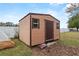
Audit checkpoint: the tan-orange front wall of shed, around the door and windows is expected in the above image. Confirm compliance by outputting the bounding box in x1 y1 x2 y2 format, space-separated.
31 15 59 45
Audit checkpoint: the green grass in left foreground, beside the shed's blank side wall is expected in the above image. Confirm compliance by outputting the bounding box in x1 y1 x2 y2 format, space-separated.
0 39 32 56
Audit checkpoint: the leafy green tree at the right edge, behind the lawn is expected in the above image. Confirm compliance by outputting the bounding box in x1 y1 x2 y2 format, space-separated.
68 14 79 31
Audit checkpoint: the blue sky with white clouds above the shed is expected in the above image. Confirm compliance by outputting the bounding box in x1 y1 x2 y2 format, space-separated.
0 3 69 28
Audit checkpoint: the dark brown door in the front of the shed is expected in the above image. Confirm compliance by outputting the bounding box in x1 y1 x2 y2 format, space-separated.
45 20 53 42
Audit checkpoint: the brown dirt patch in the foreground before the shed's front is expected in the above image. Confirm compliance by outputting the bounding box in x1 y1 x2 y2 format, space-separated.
32 43 79 56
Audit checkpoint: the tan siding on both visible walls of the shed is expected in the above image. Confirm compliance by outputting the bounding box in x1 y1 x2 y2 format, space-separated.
19 15 60 46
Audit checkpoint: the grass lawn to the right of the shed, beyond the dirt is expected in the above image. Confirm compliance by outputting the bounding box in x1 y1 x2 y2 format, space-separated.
59 32 79 46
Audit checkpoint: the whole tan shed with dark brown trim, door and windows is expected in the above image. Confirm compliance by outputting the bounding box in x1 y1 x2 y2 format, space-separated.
19 13 60 47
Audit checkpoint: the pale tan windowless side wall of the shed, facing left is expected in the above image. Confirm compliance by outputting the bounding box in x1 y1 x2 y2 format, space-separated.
19 15 30 45
